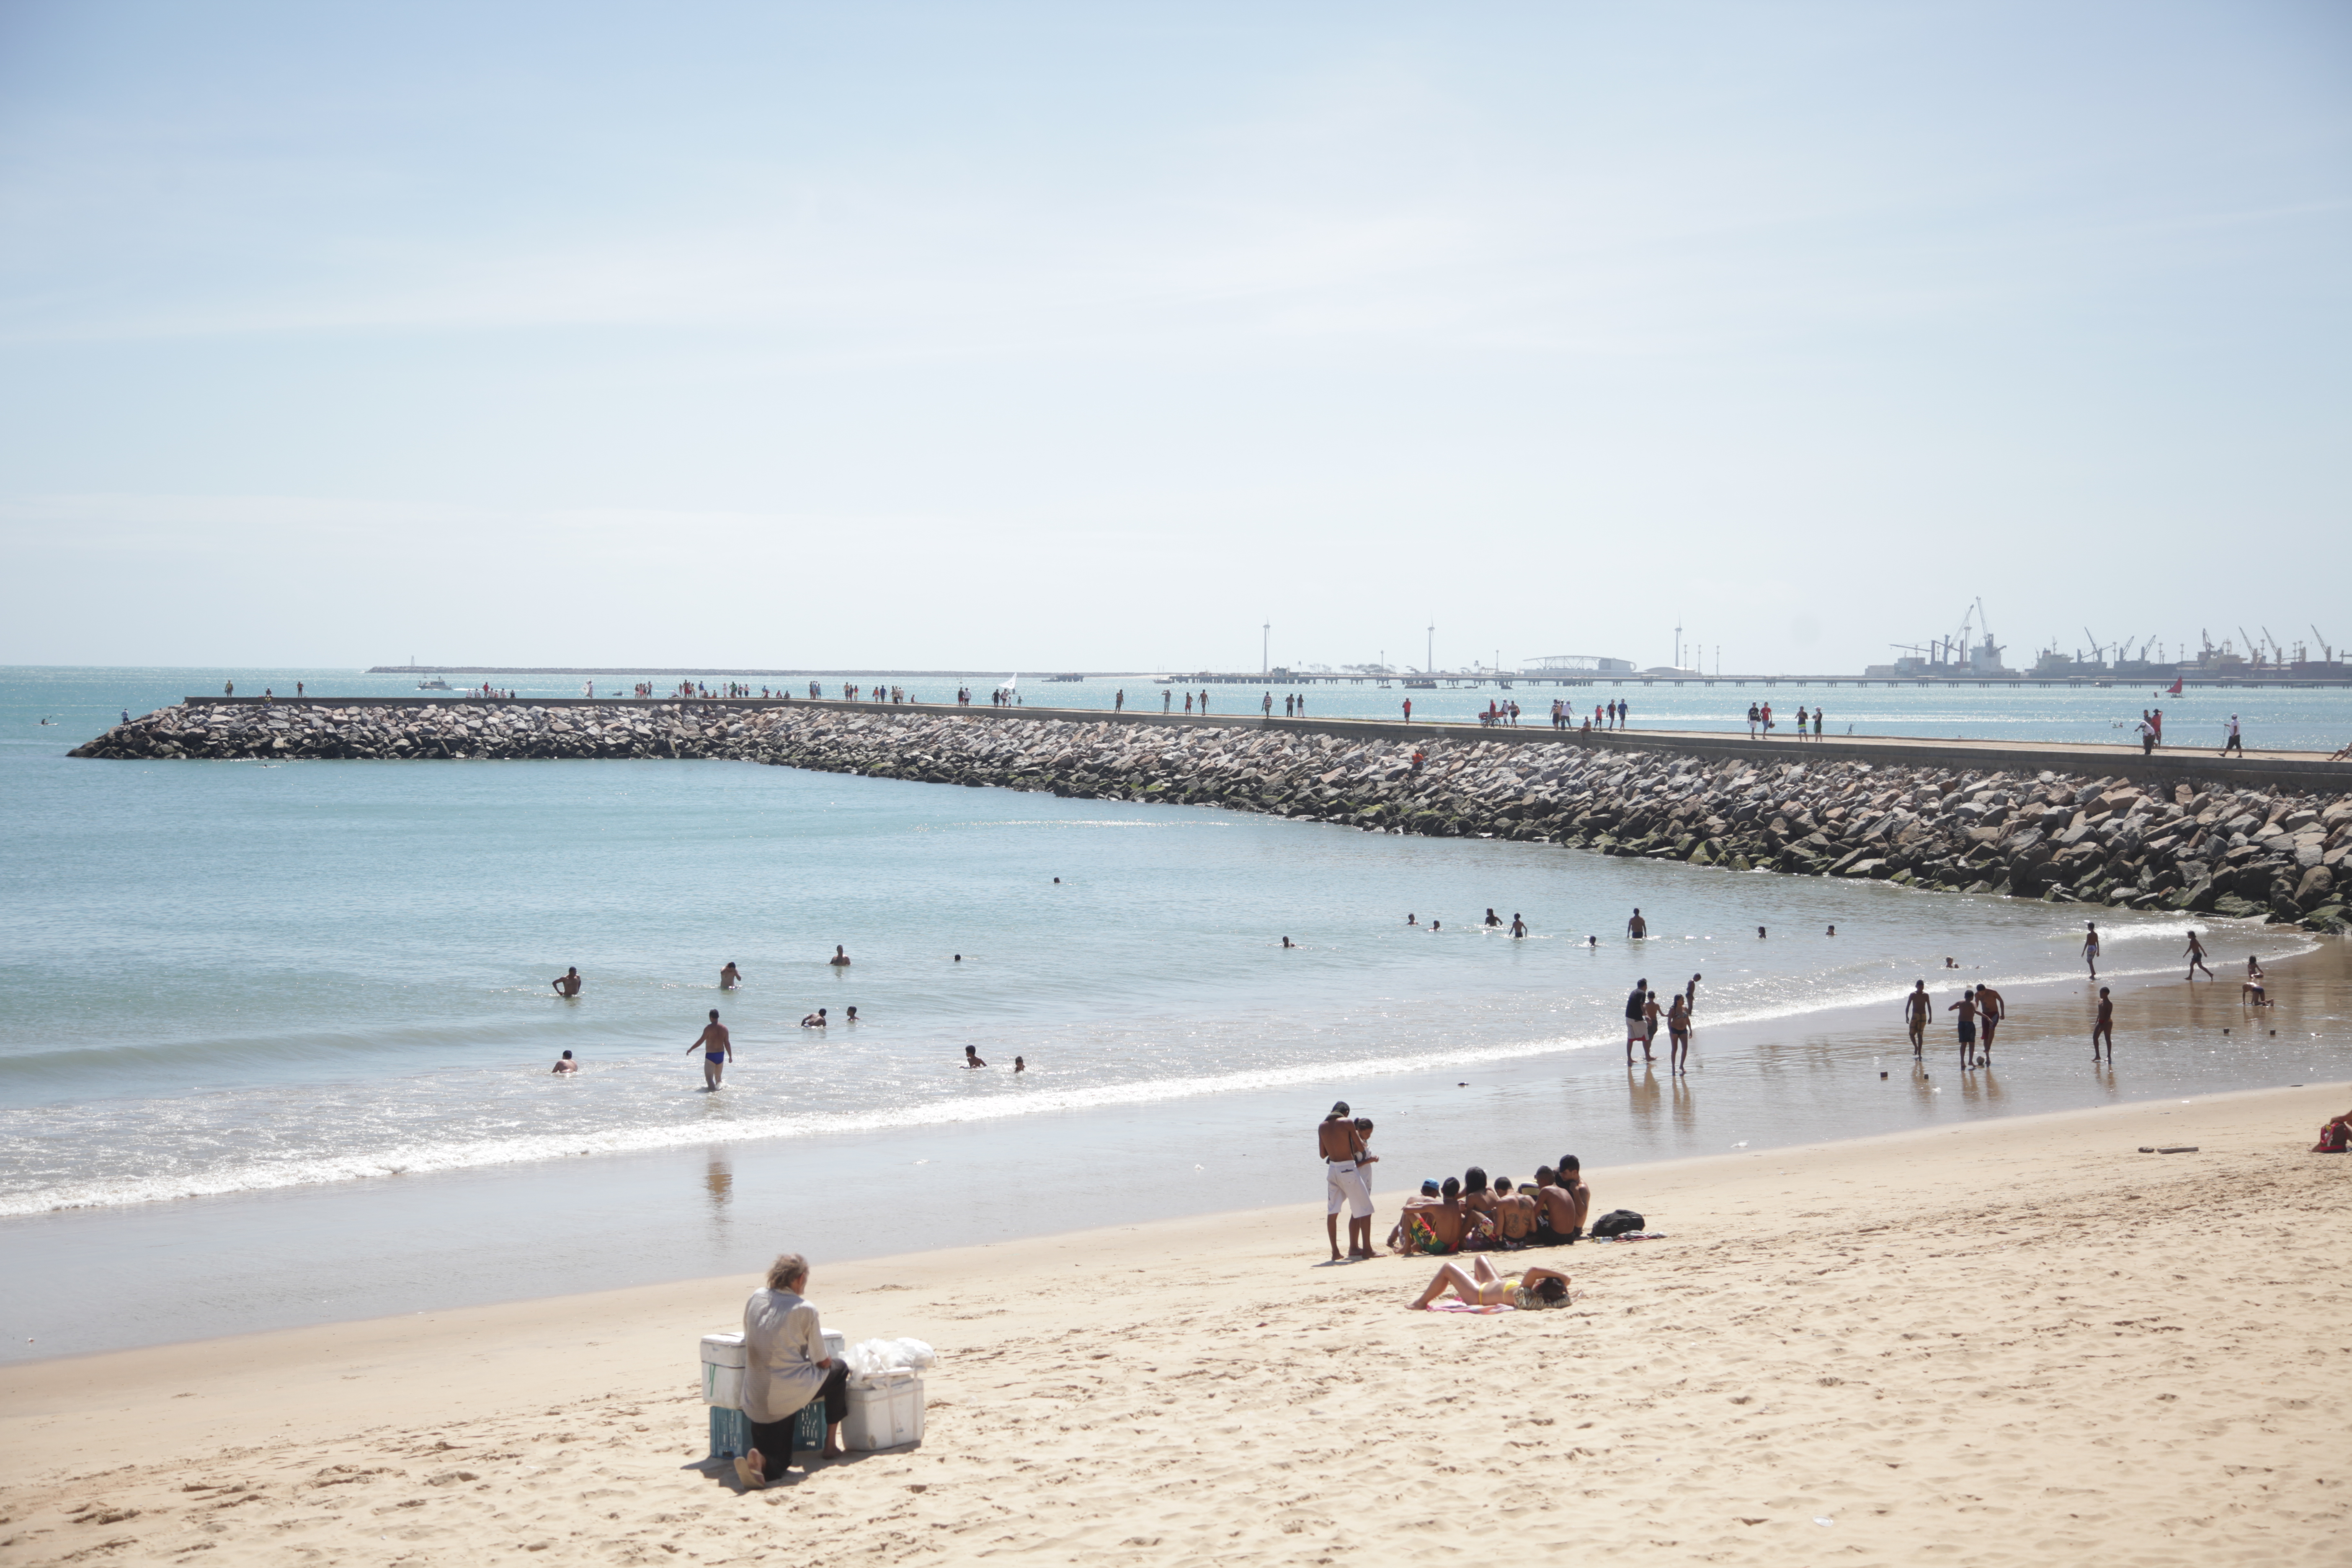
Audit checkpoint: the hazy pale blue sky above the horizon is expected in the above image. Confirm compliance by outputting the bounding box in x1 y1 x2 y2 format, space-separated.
0 0 2352 670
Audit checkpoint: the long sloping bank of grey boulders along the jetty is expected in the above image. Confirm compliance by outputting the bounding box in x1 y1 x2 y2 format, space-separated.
73 698 2352 933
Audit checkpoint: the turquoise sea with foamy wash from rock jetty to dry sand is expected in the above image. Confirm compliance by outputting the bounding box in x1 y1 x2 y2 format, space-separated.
0 670 2352 1357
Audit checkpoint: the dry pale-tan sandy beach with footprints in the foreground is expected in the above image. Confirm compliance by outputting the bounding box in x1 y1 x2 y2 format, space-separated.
0 1067 2352 1563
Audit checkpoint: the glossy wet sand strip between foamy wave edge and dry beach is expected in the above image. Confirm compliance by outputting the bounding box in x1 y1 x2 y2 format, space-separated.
0 938 2352 1366
